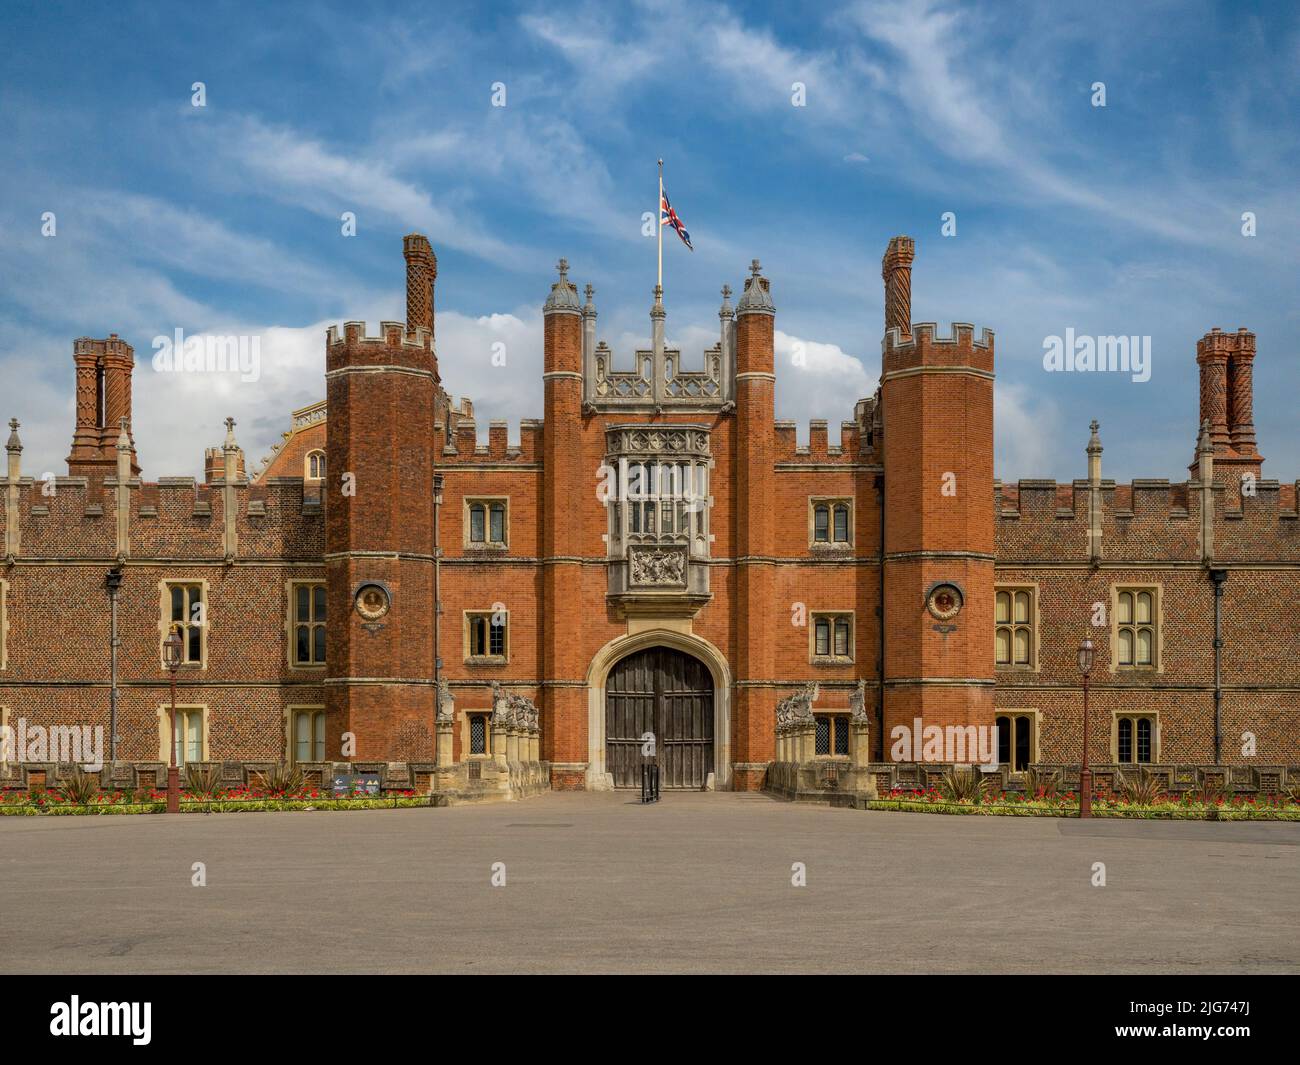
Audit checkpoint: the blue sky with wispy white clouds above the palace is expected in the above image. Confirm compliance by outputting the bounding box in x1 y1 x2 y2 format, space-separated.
0 3 1300 480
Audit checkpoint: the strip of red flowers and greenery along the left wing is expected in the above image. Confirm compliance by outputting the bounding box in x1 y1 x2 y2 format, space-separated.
0 788 432 817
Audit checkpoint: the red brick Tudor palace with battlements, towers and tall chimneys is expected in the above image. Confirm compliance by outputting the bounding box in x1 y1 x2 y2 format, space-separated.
0 235 1300 788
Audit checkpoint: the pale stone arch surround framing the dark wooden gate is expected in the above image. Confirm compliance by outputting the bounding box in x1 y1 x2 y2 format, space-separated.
585 628 731 791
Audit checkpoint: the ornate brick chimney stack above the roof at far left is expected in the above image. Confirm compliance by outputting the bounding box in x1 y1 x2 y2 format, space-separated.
68 333 140 477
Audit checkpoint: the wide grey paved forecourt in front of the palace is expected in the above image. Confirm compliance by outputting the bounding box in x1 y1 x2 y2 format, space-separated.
0 792 1300 973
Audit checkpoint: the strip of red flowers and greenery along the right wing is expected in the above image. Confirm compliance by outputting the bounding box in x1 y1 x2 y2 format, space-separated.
867 788 1300 821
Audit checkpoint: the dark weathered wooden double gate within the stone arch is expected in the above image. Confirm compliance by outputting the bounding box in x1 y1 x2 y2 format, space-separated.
605 648 714 788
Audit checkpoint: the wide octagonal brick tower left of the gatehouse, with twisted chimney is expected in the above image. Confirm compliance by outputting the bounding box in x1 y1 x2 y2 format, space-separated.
324 234 438 762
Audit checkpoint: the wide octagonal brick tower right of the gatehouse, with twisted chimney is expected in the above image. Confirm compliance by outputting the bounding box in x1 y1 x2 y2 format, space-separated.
880 237 995 758
